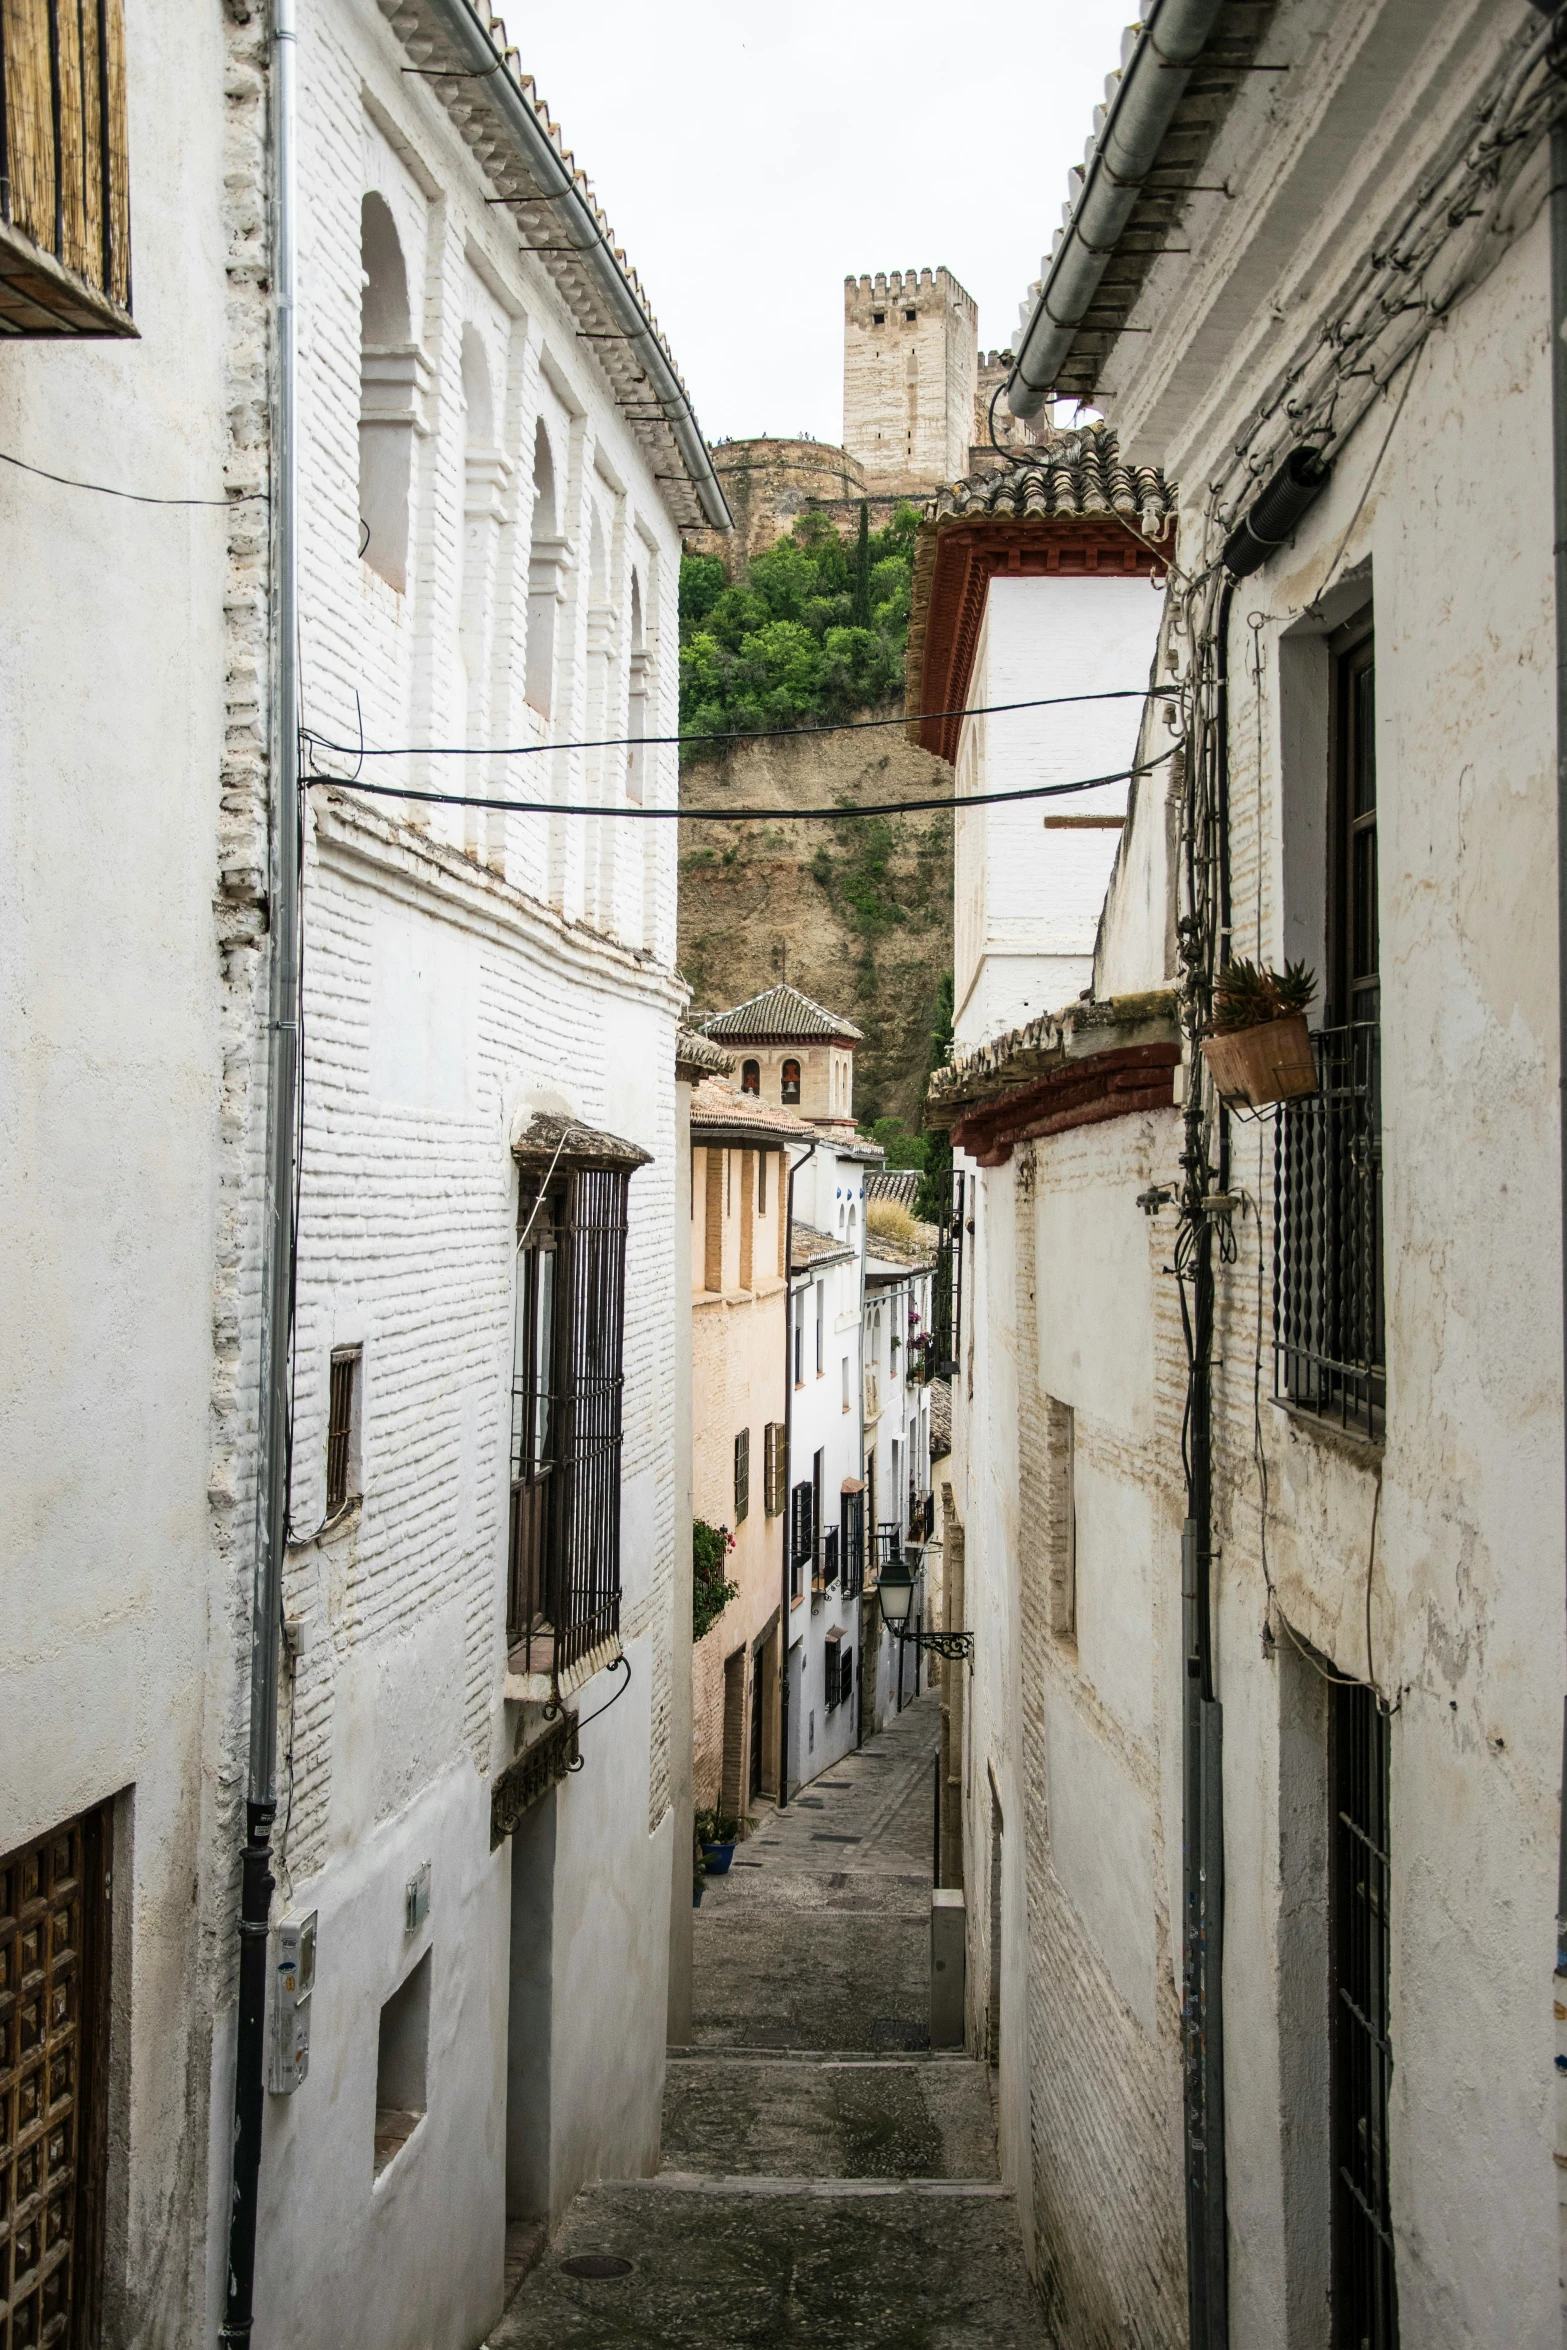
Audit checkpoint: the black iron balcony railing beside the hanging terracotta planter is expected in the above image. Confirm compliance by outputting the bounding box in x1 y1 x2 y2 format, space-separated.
1273 1020 1386 1436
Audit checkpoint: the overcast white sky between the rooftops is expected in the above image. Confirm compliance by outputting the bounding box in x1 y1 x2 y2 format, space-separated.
521 0 1135 442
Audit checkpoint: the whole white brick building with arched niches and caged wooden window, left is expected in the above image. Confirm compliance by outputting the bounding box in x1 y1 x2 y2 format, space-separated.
240 0 724 2350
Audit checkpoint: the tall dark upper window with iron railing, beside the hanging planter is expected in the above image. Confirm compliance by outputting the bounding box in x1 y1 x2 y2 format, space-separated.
1273 625 1386 1436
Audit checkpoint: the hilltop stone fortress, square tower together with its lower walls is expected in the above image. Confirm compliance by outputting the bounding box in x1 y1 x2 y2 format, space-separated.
686 268 1041 571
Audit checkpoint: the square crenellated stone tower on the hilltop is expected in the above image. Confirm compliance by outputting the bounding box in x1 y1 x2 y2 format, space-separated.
843 270 980 494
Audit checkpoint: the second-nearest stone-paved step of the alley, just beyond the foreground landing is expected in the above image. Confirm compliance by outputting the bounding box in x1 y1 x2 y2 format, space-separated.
663 2056 996 2178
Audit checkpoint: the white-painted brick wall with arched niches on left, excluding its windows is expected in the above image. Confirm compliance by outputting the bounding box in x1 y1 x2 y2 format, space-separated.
239 0 691 2350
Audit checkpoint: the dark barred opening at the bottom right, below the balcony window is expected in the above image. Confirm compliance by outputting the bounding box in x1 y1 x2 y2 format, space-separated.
1327 1683 1398 2350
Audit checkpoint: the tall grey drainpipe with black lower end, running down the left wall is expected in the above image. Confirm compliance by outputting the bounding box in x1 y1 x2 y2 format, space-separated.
218 0 301 2350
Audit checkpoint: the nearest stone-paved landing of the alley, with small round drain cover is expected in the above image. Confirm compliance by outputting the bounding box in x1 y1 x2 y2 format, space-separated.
489 2183 1050 2350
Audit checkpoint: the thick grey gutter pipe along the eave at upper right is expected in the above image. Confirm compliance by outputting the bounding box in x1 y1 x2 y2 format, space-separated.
1006 0 1224 416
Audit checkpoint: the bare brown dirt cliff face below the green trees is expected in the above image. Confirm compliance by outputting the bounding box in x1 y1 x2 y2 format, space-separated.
679 726 951 1128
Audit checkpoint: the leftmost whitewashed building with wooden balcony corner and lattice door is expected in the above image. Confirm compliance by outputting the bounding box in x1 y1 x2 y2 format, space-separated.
0 0 247 2350
